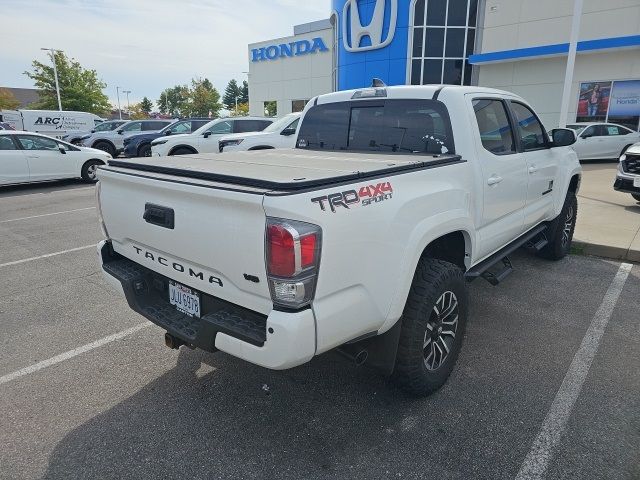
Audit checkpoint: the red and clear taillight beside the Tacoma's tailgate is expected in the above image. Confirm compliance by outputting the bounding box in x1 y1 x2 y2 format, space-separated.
265 218 322 308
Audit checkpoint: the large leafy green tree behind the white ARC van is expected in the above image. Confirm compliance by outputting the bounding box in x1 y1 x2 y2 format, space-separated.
24 51 111 115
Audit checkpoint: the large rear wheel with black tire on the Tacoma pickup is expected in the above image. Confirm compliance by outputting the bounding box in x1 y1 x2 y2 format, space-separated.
392 258 469 396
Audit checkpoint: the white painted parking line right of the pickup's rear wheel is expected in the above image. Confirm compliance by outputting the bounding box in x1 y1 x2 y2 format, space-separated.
516 263 633 480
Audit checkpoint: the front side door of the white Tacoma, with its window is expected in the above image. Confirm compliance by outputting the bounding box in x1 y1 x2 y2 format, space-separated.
509 101 562 230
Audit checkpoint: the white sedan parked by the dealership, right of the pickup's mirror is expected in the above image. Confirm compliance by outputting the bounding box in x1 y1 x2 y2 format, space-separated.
567 123 640 160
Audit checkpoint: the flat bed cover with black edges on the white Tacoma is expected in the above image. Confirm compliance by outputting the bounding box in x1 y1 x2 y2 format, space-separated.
103 149 461 193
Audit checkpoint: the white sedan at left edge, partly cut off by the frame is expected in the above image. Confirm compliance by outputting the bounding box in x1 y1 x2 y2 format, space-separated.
0 130 111 185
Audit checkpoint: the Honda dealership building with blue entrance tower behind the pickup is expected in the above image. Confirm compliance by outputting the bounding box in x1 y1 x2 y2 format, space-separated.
248 0 640 130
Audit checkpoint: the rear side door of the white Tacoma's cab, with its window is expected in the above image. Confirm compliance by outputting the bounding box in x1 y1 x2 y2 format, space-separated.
468 96 527 258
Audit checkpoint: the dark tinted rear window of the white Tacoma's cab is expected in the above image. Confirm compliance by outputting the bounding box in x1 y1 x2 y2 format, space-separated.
298 100 455 155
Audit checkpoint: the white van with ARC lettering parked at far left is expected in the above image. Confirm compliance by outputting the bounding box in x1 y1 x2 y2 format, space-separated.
0 110 104 138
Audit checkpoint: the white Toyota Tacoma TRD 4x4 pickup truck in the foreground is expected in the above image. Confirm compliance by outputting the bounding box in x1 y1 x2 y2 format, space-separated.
98 85 581 395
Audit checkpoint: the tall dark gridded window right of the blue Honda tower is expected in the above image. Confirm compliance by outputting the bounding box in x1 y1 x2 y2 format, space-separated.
411 0 478 85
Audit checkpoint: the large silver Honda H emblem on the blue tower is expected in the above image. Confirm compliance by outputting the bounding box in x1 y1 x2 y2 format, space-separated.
342 0 398 52
